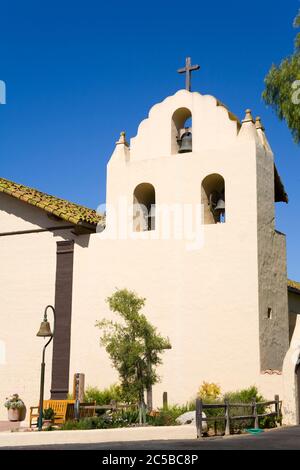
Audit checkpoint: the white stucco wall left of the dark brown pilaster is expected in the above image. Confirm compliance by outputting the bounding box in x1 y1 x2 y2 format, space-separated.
0 194 74 420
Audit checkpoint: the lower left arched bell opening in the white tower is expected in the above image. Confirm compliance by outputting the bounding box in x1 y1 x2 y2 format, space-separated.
133 183 155 232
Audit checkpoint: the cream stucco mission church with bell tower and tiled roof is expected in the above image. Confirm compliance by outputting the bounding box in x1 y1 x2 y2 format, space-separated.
0 67 300 424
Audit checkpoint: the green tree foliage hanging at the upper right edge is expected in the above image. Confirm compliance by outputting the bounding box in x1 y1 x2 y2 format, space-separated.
262 11 300 143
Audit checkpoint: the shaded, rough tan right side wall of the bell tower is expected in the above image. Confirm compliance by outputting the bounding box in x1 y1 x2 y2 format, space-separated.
256 143 289 372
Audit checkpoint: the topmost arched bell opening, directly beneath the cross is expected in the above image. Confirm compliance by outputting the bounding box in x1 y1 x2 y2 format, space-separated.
171 108 193 154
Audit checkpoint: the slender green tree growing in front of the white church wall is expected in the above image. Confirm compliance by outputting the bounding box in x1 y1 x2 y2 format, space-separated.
96 289 171 422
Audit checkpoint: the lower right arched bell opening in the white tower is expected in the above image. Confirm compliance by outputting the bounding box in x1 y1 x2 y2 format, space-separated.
201 173 226 224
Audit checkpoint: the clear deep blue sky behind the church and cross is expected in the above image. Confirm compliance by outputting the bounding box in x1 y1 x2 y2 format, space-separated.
0 0 300 280
